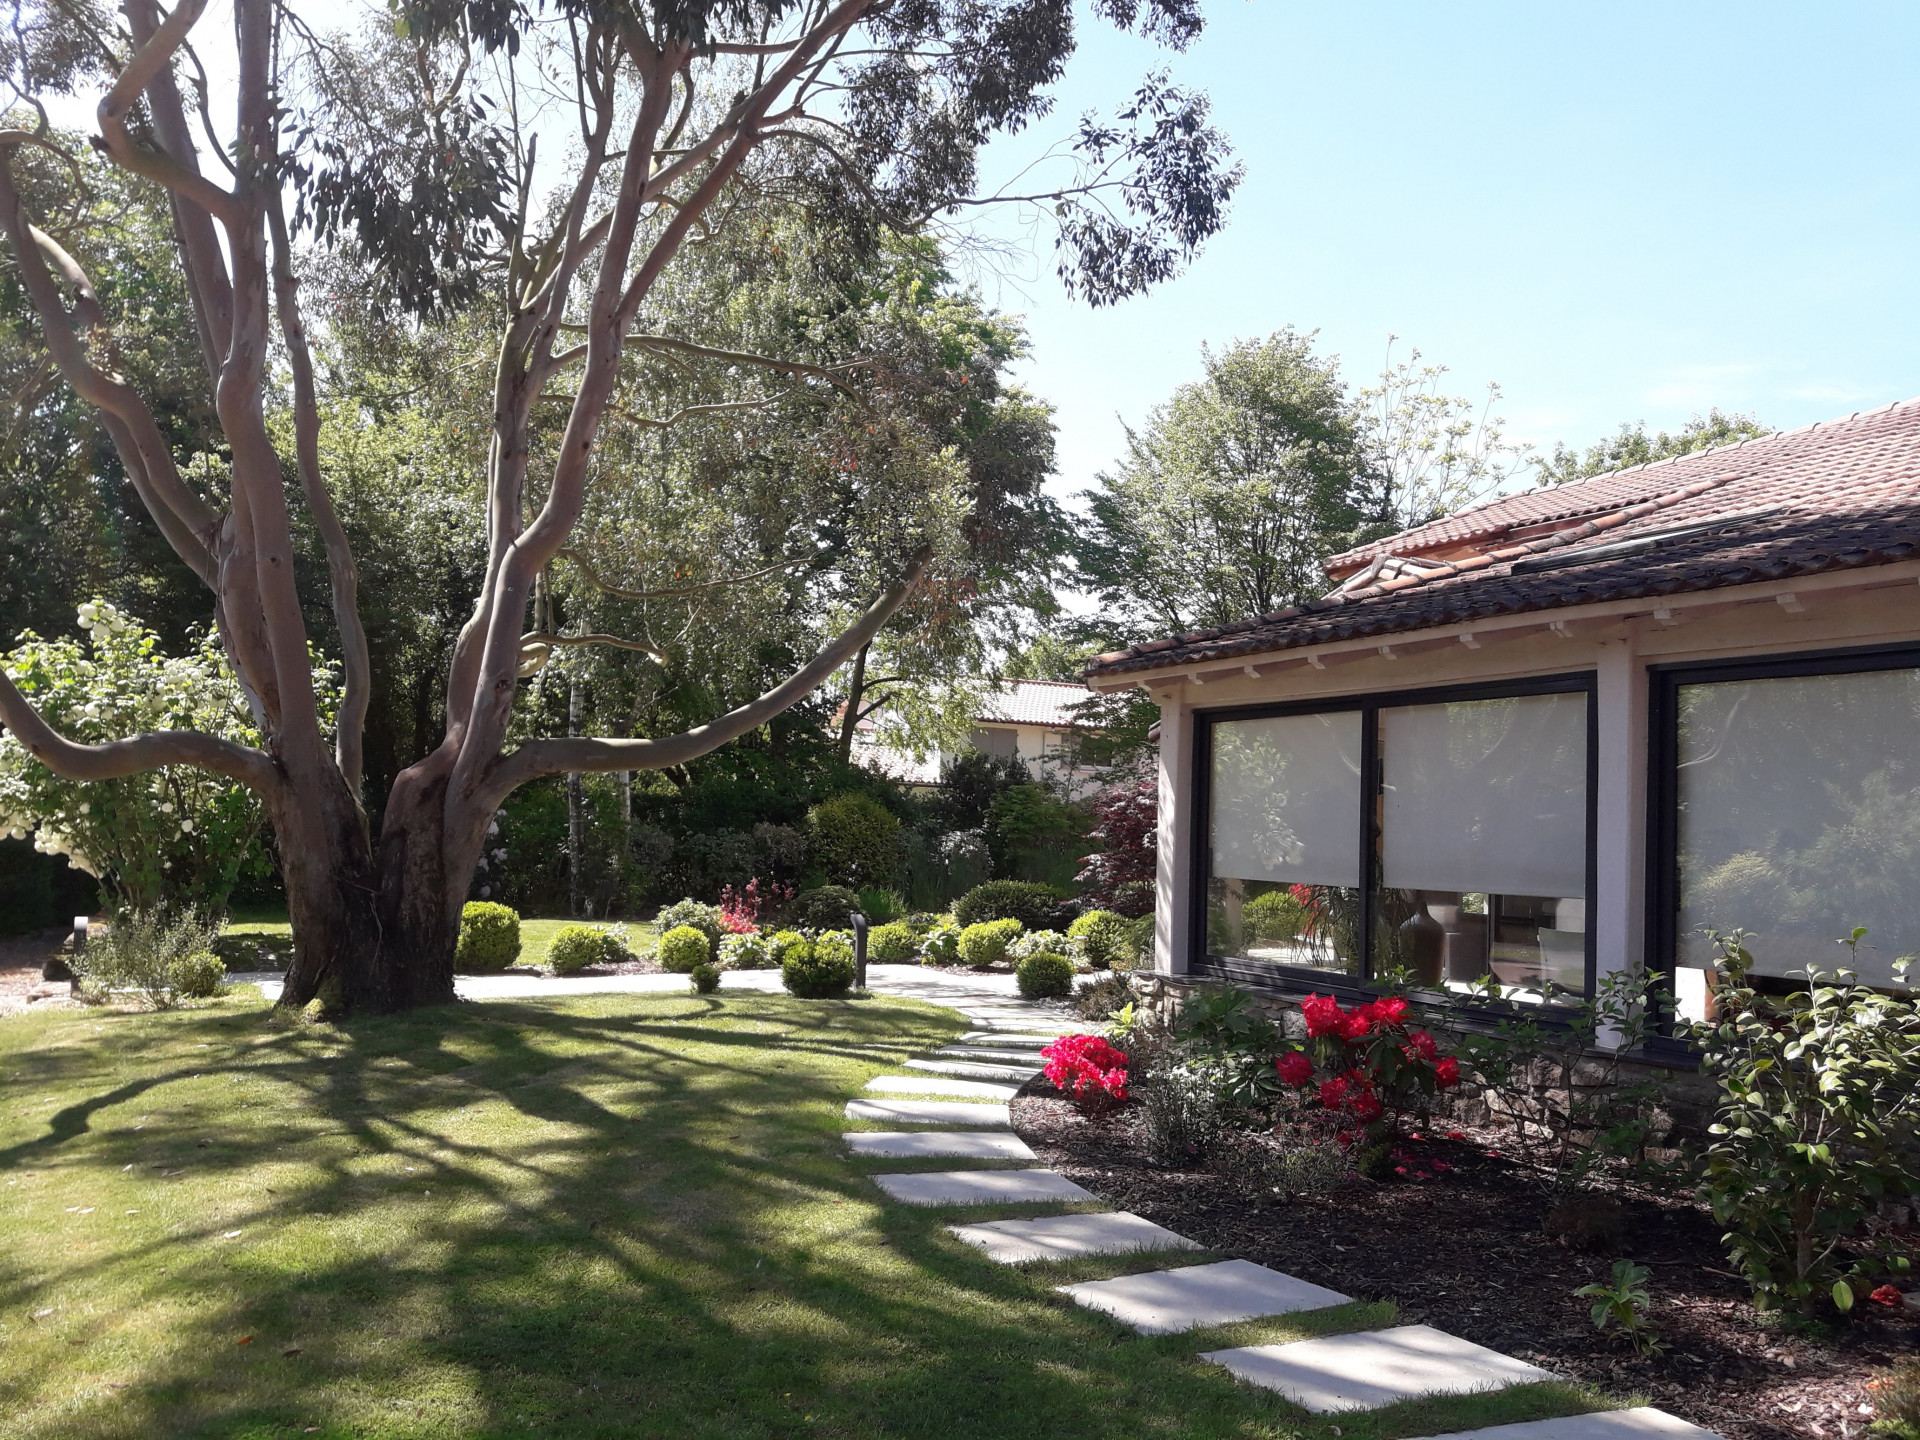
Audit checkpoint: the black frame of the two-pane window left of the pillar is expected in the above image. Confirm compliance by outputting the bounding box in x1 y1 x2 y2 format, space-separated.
1187 670 1599 1014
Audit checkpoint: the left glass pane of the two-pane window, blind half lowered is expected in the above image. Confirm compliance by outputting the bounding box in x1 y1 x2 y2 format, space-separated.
1208 710 1361 975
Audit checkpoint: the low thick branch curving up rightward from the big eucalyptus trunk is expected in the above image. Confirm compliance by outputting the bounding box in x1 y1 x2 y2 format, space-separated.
482 551 931 810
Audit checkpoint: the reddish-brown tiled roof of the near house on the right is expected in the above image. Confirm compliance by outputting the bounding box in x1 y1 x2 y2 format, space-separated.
1087 399 1920 678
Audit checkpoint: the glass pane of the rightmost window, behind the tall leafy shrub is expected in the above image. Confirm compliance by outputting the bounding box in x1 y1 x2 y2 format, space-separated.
1676 670 1920 1020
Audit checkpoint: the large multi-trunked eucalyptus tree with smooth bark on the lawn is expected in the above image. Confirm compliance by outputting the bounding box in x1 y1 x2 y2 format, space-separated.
0 0 1238 1008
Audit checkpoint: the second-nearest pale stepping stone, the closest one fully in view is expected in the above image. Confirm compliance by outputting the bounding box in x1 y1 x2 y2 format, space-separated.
1200 1325 1561 1415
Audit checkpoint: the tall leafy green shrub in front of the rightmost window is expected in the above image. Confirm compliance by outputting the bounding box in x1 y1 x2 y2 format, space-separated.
1693 929 1920 1313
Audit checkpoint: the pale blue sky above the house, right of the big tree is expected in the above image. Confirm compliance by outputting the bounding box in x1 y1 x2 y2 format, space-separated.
981 0 1920 493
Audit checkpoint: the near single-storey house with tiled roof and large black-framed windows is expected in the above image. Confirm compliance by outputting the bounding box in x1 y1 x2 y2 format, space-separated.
1087 399 1920 1052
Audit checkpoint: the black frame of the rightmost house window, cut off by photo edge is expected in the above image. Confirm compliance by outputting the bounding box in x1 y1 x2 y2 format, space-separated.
1644 641 1920 1037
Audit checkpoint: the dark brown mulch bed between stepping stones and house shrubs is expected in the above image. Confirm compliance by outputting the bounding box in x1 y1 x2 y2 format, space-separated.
1014 1081 1920 1440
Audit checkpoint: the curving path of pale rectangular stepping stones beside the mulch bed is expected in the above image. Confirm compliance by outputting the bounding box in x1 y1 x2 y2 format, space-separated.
845 975 1720 1440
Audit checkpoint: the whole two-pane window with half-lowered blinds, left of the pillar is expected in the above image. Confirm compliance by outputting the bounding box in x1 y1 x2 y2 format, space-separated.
1196 676 1592 1000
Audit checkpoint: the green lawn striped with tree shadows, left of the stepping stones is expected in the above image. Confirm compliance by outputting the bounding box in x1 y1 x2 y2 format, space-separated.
0 991 1605 1440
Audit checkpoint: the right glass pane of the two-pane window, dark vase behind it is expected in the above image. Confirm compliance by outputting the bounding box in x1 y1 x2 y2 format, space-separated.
1373 693 1588 1000
